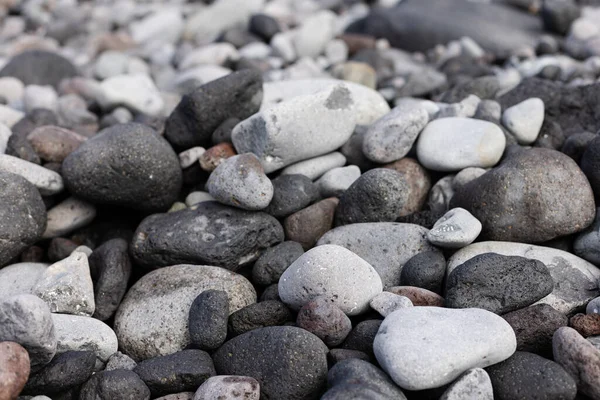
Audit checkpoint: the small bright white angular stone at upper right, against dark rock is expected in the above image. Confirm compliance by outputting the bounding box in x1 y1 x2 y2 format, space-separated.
502 97 544 144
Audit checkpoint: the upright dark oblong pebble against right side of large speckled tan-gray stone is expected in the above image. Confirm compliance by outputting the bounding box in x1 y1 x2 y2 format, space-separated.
189 289 229 350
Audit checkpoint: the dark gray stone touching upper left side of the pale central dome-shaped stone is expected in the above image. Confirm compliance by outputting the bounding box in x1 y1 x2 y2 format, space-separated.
252 240 304 286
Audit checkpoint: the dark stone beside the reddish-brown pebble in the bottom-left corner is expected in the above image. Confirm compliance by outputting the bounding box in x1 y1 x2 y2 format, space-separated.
22 351 96 395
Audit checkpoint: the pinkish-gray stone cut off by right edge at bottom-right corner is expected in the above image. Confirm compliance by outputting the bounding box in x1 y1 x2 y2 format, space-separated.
552 327 600 399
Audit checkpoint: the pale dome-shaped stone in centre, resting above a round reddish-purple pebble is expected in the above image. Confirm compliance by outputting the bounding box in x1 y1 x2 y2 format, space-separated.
278 245 383 315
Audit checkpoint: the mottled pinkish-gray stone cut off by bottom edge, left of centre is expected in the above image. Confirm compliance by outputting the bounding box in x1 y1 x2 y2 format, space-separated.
193 375 260 400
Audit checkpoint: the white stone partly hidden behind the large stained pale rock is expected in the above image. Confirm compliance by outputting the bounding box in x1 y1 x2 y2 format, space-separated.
261 79 390 125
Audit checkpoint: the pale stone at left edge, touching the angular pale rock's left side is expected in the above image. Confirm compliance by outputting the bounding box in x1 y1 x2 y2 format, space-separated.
0 262 50 298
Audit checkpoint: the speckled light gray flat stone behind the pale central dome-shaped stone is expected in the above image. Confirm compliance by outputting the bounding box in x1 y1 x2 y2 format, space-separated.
317 222 437 287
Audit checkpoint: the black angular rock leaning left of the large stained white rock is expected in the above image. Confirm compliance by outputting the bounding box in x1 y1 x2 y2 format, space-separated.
165 70 263 150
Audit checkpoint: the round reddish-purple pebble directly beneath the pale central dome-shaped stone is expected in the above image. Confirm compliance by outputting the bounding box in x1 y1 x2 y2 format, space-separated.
296 297 352 347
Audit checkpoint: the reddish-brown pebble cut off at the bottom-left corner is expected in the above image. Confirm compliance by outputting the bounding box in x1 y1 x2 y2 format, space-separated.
0 342 29 400
